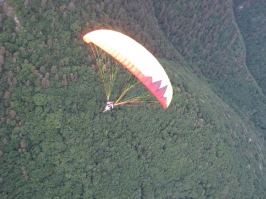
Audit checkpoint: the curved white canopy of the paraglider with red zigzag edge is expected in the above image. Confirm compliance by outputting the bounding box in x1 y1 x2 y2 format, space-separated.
83 30 173 109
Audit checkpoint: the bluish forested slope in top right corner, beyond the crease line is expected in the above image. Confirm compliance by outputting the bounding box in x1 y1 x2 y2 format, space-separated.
234 0 266 95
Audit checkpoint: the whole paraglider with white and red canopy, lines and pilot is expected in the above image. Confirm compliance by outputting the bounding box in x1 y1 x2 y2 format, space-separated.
83 30 173 112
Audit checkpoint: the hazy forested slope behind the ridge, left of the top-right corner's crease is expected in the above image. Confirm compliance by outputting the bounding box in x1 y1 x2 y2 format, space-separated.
155 1 266 134
